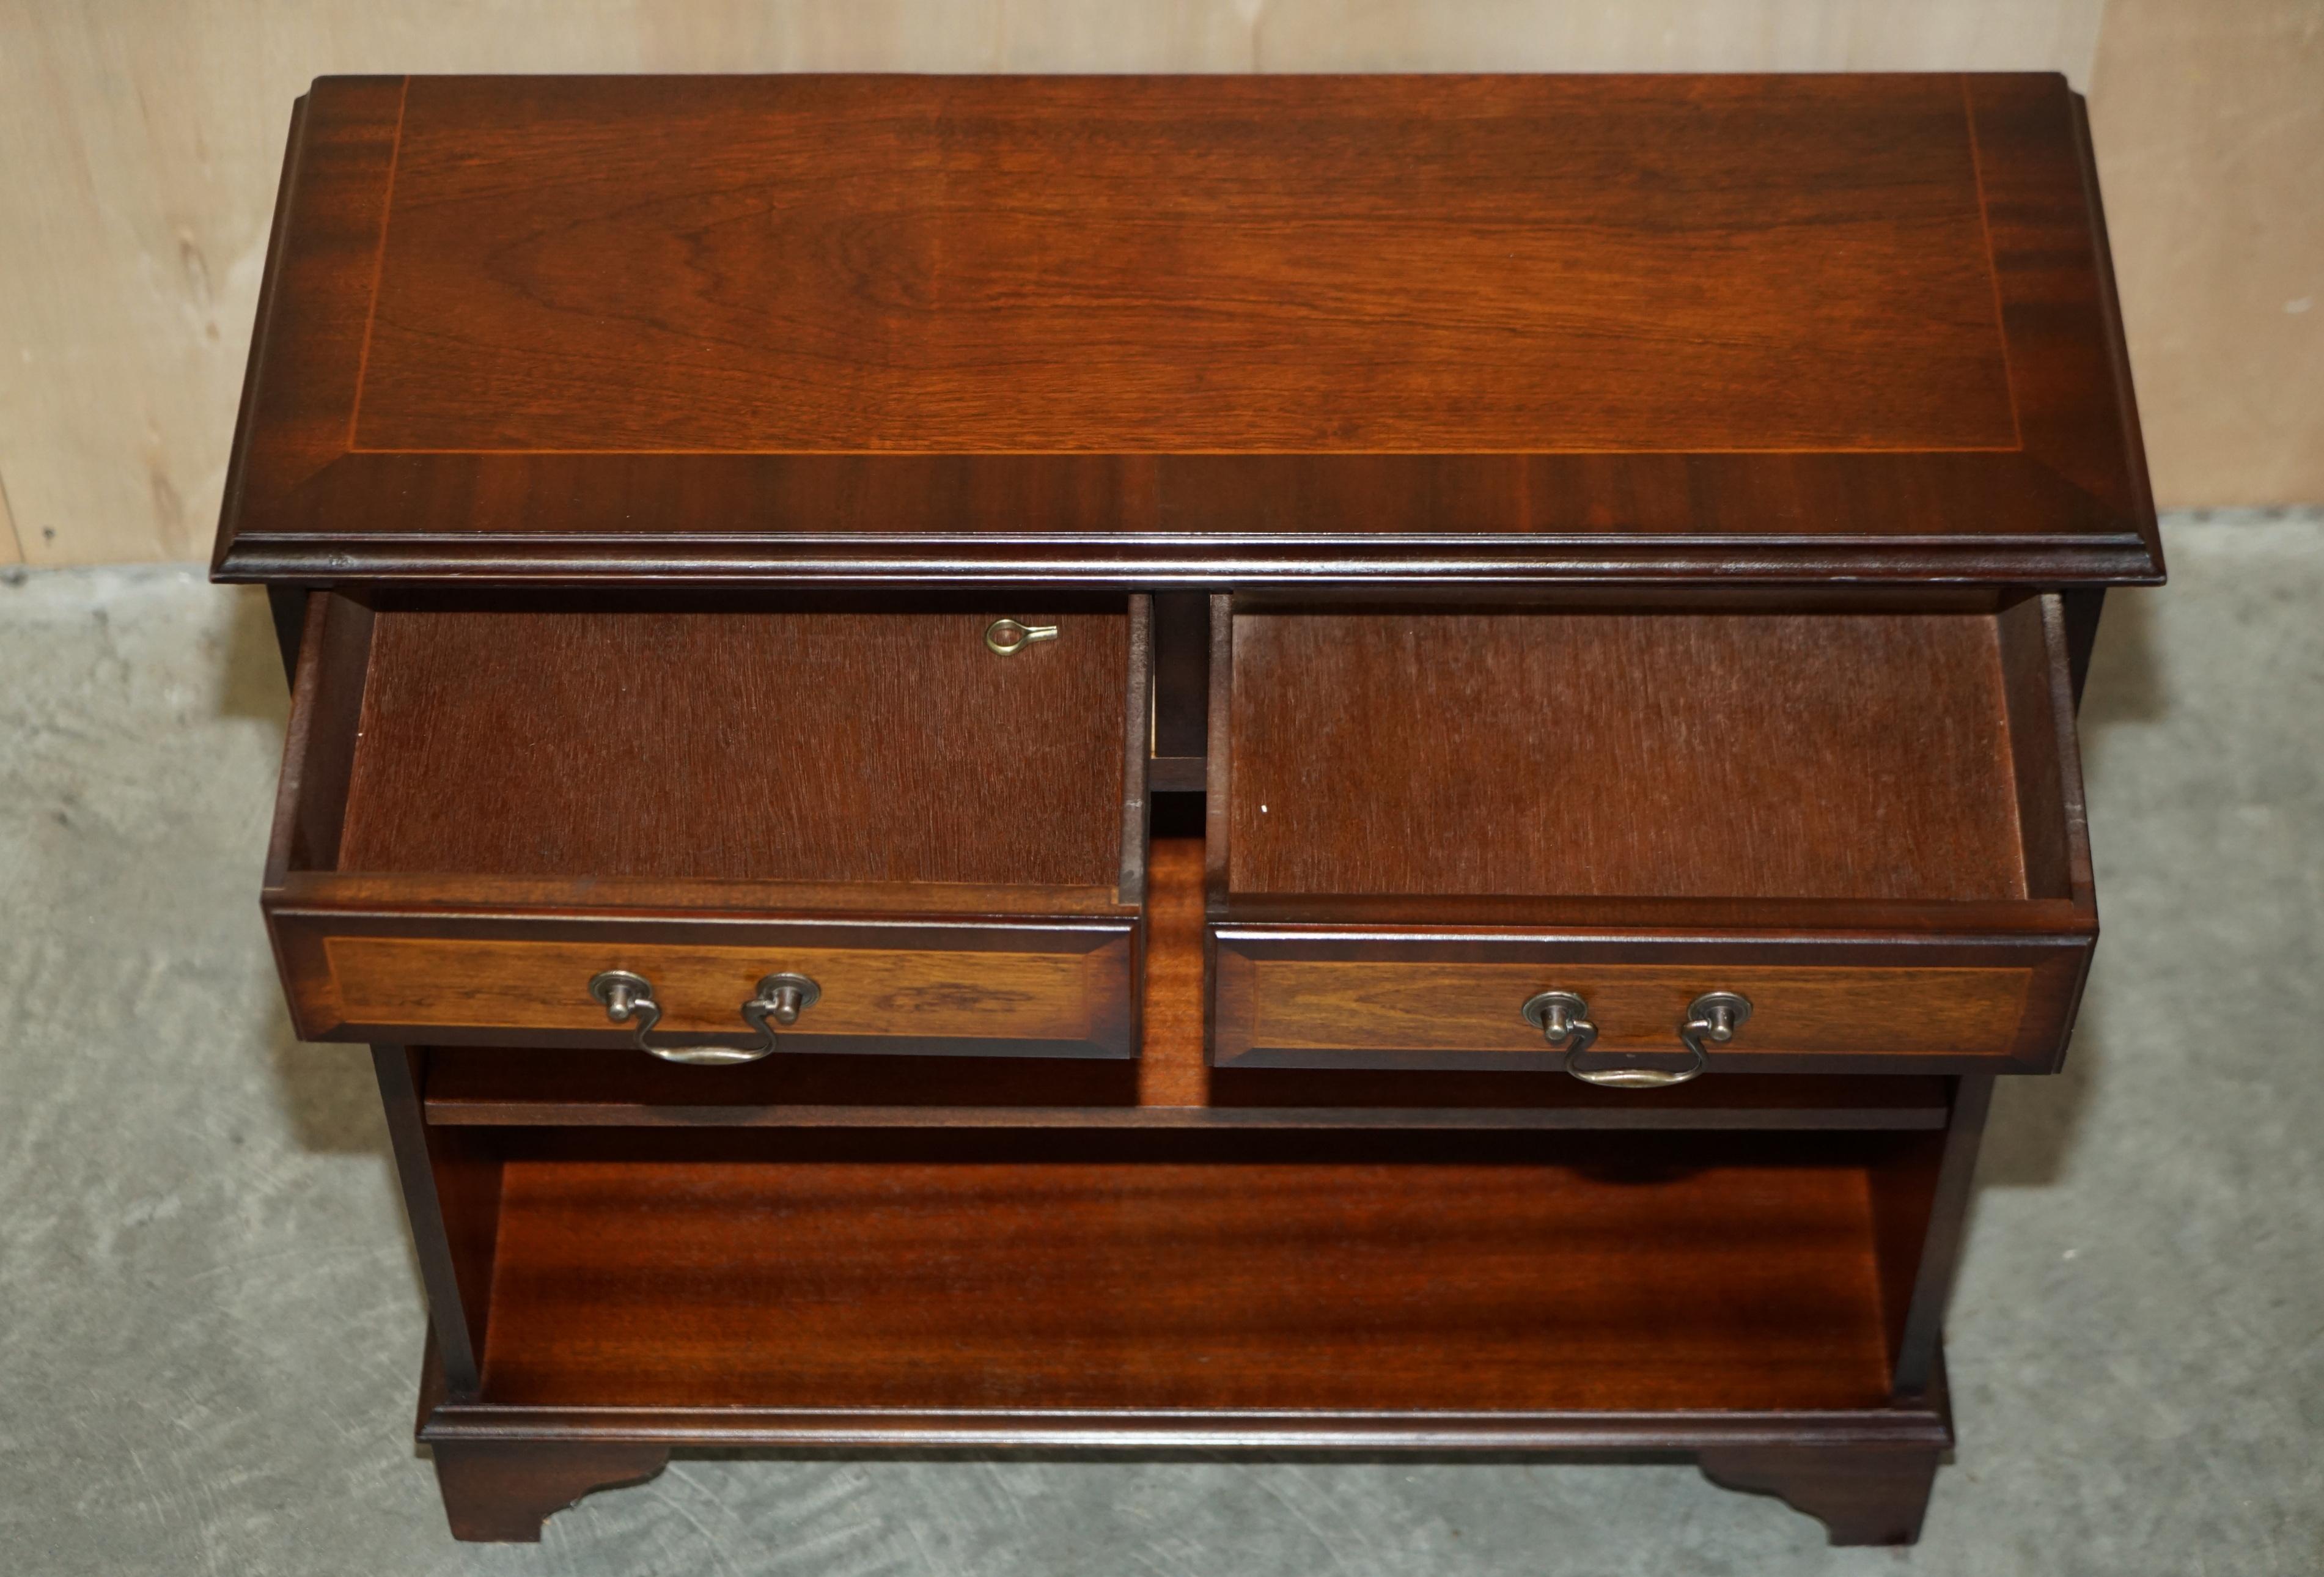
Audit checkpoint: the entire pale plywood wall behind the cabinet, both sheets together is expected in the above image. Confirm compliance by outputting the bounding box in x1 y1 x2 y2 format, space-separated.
0 0 2324 564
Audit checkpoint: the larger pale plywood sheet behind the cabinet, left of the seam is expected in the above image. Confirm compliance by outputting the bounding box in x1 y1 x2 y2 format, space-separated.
0 0 2103 564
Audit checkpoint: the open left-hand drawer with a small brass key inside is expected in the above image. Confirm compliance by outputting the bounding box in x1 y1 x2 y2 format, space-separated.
265 595 1148 1061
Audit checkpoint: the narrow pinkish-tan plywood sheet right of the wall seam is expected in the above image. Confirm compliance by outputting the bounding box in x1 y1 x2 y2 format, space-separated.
2089 0 2324 509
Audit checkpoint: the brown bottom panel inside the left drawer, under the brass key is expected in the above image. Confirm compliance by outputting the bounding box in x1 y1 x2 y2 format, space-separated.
337 609 1130 887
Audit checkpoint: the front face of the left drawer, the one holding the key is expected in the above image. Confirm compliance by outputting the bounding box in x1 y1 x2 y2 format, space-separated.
274 915 1136 1057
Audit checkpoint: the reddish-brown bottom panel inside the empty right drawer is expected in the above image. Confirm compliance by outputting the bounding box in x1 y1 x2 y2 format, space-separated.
1229 613 2026 901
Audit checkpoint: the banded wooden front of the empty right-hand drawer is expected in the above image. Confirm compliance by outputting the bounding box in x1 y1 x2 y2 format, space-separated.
1208 924 2096 1073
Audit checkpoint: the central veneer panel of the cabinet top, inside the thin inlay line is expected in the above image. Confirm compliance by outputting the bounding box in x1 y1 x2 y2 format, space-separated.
353 76 2017 453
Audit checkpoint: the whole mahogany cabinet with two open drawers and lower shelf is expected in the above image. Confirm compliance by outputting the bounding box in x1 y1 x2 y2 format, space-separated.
214 75 2161 1542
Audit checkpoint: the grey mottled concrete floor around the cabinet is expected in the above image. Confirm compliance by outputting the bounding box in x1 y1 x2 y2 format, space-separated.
0 513 2324 1577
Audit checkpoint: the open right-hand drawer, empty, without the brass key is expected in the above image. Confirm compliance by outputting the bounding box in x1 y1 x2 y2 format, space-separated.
1206 597 2098 1084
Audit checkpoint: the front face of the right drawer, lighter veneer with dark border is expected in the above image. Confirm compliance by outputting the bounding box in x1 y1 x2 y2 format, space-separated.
1211 929 2087 1073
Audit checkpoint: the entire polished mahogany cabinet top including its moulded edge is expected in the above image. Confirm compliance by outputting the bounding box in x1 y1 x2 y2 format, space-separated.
216 76 2161 586
